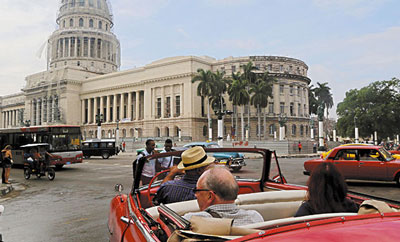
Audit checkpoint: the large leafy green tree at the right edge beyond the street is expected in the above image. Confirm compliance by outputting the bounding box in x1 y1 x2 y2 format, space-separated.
336 78 400 138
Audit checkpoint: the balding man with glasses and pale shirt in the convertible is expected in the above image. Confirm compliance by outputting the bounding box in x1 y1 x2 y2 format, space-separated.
183 166 264 226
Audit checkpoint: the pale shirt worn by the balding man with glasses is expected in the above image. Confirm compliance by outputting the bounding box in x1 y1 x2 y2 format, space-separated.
183 203 264 226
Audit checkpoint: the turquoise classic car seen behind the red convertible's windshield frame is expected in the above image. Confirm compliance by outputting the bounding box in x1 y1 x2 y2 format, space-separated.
183 142 246 172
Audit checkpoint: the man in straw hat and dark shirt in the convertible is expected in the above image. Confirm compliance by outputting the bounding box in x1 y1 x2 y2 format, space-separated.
155 146 215 203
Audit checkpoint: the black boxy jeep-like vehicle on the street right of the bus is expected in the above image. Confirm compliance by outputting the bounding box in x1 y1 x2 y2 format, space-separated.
82 139 119 159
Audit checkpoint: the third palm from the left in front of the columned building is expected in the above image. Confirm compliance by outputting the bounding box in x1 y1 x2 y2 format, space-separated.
228 73 250 140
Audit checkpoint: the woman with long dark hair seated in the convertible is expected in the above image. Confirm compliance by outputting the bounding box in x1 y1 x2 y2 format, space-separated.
295 162 358 217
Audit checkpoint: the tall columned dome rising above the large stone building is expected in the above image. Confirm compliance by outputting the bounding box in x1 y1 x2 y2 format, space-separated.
47 0 121 74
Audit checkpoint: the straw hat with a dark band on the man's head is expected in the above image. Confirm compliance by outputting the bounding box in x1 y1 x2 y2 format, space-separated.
178 146 215 170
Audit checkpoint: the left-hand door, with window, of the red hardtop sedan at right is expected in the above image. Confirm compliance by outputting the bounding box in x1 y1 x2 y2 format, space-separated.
333 149 358 179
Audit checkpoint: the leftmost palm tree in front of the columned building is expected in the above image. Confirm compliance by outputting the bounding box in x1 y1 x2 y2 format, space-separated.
192 69 213 140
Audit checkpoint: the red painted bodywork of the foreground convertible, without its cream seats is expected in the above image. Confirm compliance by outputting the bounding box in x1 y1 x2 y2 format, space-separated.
108 148 400 242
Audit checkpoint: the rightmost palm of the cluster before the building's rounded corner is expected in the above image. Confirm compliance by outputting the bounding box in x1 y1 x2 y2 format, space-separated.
250 72 274 140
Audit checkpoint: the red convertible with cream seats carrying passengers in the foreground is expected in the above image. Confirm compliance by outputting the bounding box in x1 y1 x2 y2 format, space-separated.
108 148 400 242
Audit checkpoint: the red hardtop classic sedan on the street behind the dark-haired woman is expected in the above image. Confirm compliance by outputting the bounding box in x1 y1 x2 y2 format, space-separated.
304 145 400 185
